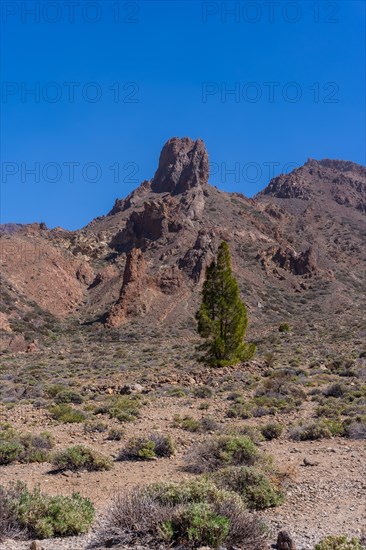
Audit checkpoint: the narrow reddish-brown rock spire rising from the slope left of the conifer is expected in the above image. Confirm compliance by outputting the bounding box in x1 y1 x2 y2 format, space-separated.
105 248 147 327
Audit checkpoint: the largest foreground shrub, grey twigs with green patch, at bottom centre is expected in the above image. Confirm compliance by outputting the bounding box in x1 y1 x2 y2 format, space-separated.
96 479 266 550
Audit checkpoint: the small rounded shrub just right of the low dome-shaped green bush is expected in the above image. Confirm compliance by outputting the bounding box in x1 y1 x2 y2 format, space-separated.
118 433 175 460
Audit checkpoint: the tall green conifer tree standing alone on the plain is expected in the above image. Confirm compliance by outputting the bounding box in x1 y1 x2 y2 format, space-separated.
196 242 255 366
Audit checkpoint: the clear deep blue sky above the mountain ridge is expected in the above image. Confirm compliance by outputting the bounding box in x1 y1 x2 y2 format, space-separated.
1 0 365 229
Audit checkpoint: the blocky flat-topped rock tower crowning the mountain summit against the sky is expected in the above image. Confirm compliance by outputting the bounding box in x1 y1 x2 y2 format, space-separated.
151 138 209 195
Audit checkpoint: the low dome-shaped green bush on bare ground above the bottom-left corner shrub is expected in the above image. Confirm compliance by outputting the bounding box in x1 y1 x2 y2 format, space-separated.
52 445 113 471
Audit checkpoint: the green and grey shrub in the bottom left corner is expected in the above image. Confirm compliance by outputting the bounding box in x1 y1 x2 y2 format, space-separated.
0 482 94 540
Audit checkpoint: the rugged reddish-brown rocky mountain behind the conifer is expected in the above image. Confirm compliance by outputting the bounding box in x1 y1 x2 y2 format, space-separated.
0 138 366 350
